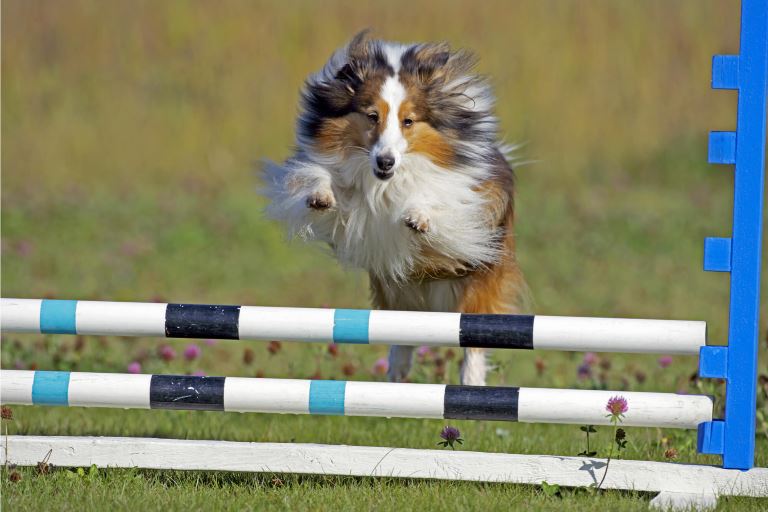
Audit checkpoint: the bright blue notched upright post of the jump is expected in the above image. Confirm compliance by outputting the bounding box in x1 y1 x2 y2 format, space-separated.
698 0 768 469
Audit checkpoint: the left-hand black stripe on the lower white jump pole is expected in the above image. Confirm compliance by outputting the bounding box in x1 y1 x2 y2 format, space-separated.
149 375 226 411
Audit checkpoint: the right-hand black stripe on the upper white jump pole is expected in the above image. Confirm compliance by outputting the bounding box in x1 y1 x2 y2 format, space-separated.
459 314 533 349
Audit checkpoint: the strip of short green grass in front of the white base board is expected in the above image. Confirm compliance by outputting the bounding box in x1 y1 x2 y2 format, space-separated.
14 470 764 511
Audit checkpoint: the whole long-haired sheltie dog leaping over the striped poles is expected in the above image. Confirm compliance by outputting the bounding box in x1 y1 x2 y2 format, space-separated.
265 32 525 385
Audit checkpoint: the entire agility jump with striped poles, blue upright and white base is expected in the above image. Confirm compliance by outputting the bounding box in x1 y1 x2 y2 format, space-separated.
0 0 768 507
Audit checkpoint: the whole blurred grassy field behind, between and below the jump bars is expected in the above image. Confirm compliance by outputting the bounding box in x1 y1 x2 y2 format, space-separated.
0 0 768 510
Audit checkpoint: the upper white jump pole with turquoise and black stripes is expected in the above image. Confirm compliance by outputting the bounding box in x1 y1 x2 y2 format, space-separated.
0 299 707 355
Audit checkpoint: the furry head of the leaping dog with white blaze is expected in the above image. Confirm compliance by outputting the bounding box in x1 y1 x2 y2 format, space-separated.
299 32 497 180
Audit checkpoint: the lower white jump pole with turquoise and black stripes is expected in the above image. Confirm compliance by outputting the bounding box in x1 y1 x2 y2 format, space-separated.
0 370 712 429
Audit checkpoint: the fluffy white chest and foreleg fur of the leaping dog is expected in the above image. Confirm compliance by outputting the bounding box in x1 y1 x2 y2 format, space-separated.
276 155 499 282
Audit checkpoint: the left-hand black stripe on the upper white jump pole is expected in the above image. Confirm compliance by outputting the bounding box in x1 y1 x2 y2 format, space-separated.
165 304 240 340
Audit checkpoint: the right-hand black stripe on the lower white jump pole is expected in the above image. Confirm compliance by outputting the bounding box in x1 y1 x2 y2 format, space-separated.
443 385 520 421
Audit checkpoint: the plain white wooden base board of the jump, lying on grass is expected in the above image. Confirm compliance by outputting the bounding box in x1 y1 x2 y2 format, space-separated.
0 436 768 508
